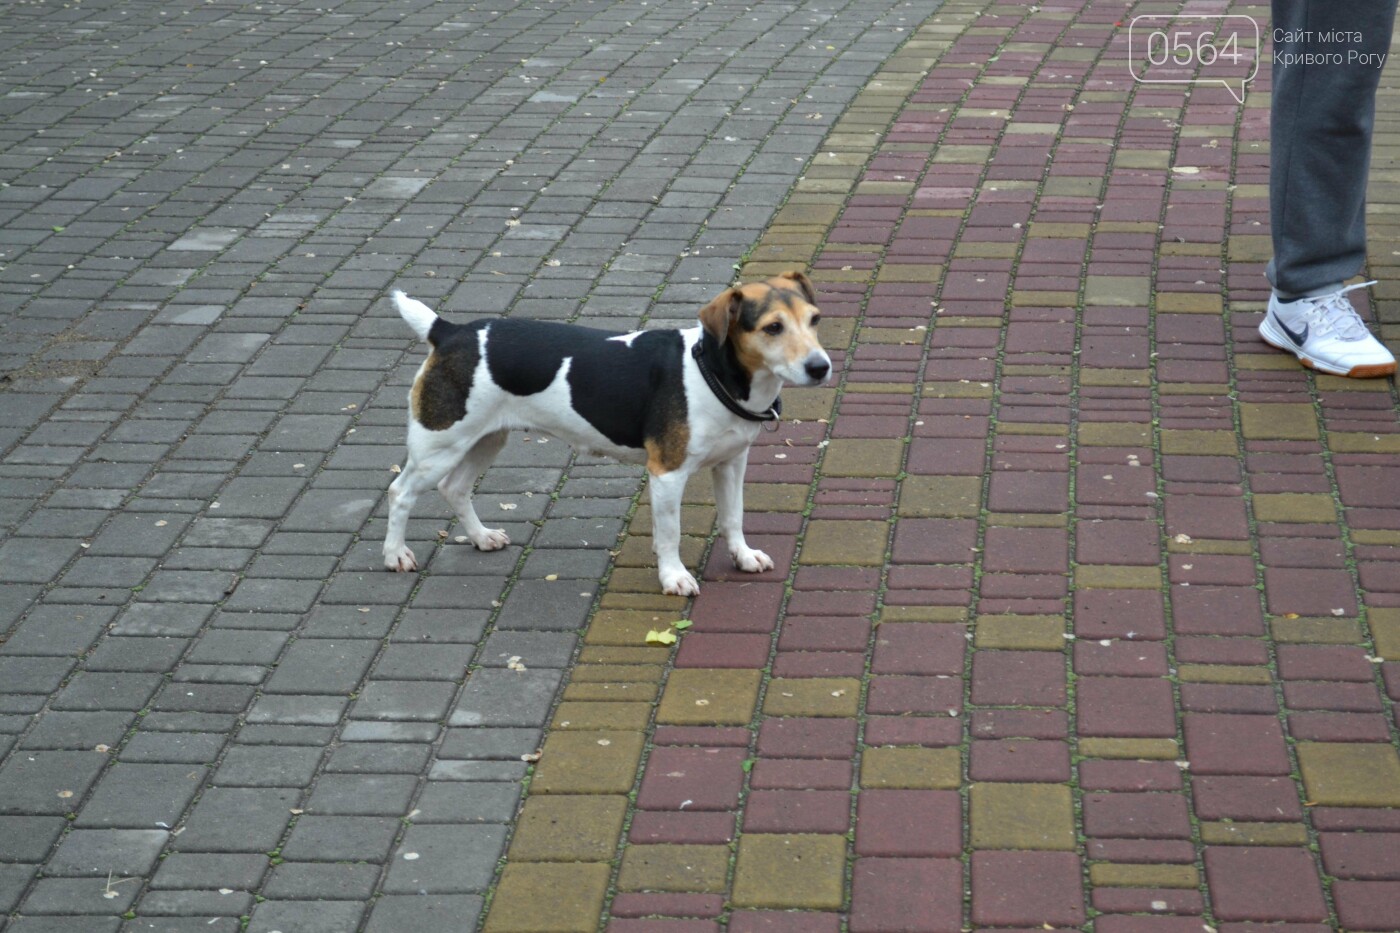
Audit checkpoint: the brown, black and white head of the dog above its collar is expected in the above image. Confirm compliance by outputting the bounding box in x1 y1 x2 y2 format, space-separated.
700 272 832 385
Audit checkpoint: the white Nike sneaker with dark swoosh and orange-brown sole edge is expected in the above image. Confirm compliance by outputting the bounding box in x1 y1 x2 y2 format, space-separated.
1259 282 1396 378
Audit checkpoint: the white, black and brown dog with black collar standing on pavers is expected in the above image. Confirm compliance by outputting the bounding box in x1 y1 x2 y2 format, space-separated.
384 272 832 595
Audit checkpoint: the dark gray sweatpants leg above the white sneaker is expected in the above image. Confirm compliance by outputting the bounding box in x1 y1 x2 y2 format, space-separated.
1266 0 1397 298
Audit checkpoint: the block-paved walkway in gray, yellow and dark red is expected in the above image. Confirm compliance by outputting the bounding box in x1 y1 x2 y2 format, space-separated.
0 0 1400 933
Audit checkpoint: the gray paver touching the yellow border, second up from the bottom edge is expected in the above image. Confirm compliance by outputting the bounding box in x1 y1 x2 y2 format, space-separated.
384 824 505 894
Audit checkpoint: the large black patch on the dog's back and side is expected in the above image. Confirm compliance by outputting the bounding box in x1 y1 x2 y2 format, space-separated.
486 319 686 448
